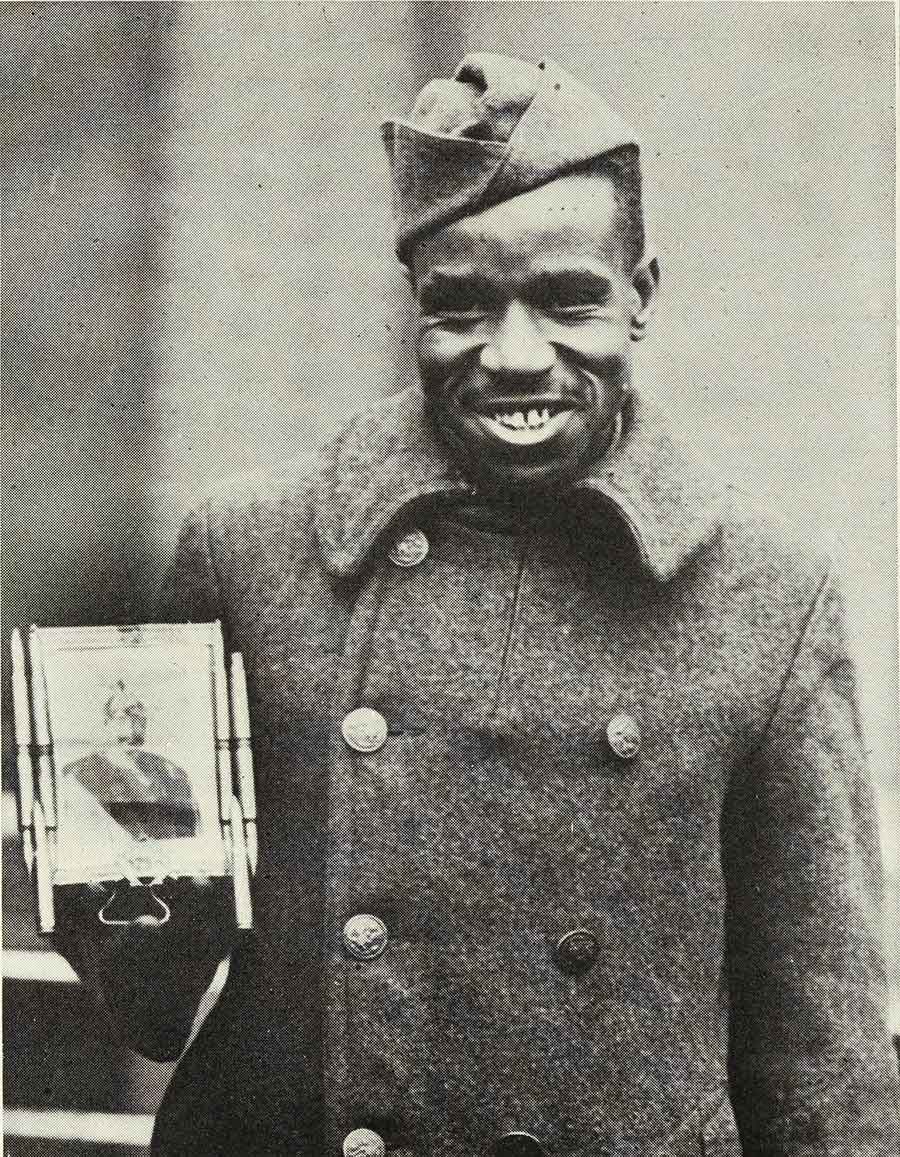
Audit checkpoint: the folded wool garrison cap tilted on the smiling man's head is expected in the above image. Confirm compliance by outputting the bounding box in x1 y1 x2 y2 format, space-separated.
382 52 637 264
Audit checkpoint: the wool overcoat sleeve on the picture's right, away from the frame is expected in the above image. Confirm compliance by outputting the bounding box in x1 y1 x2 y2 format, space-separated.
723 577 900 1157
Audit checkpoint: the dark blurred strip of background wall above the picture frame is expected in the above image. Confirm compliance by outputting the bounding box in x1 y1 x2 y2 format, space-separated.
0 3 172 626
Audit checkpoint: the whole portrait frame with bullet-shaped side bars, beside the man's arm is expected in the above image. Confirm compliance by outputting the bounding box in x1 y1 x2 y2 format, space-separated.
13 622 257 931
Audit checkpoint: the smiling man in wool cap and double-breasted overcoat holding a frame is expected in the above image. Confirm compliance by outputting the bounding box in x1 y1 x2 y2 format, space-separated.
64 54 898 1157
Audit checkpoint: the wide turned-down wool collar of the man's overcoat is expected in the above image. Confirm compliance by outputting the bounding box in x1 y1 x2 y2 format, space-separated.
316 386 720 582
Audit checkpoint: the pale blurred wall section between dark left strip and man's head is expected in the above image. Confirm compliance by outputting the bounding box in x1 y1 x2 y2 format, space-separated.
156 3 416 532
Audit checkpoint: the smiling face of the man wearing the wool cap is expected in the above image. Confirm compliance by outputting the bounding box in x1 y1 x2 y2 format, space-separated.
412 176 656 492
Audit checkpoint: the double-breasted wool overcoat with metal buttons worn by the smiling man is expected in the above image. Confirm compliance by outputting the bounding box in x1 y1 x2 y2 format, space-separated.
155 389 898 1157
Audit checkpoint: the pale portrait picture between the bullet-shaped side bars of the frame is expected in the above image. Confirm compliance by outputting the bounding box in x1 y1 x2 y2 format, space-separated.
30 624 230 884
